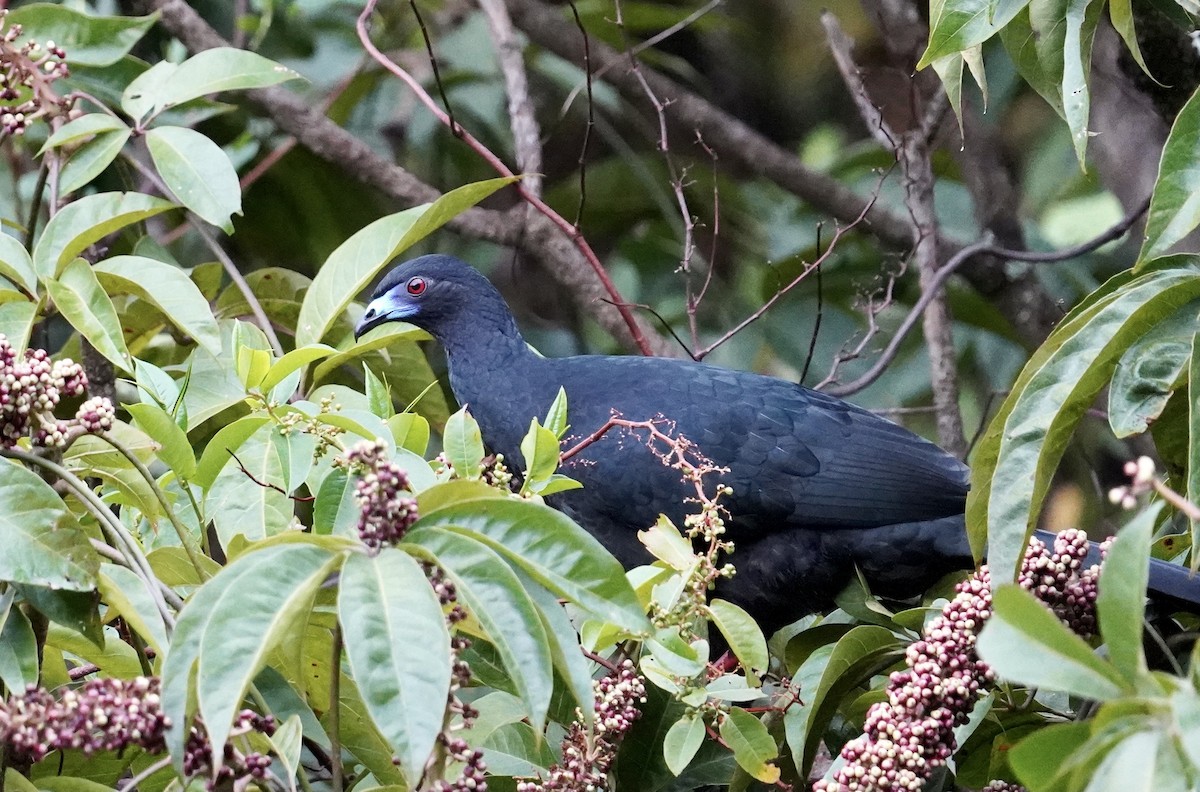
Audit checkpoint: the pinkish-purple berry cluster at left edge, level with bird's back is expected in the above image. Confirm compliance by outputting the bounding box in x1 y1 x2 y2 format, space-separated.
0 335 115 448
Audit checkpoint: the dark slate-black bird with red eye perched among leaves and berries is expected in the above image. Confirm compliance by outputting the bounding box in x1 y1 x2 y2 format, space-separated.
355 254 1200 635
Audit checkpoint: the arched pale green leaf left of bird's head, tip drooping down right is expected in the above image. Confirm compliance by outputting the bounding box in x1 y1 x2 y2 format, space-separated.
92 256 221 355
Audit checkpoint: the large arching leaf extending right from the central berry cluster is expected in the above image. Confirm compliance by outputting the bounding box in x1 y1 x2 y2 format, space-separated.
413 498 649 632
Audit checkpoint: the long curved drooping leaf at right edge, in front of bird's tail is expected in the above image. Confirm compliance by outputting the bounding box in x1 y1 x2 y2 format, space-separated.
967 258 1200 581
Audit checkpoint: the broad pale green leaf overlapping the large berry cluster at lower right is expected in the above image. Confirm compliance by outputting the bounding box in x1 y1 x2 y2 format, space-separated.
978 584 1129 701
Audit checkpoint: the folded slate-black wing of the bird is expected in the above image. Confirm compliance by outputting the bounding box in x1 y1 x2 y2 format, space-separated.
552 358 967 532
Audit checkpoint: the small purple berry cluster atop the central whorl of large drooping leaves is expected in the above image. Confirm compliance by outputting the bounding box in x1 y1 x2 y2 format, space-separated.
346 440 418 550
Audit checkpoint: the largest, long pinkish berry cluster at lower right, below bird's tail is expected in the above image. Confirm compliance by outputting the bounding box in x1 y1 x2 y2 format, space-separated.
812 529 1099 792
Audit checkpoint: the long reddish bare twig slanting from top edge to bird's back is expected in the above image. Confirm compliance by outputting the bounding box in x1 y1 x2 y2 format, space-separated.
355 0 652 355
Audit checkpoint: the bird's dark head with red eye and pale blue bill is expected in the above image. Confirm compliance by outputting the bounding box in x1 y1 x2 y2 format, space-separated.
354 256 520 343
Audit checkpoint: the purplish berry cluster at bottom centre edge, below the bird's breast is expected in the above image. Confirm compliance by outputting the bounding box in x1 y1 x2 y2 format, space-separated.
517 660 646 792
